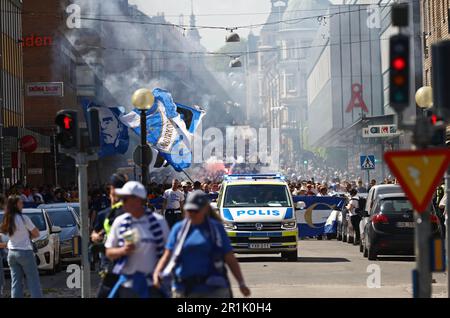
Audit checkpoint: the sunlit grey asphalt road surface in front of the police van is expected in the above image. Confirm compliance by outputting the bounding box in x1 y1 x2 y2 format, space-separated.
1 240 446 298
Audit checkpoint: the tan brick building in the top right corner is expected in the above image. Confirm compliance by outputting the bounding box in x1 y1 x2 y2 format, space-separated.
421 0 450 86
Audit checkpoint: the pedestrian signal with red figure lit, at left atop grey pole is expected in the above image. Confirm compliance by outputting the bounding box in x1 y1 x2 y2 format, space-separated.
55 110 80 153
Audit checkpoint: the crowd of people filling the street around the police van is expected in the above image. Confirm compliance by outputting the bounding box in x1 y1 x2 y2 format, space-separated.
0 165 446 298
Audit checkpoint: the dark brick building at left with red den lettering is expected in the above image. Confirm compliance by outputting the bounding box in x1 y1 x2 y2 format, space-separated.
21 0 79 185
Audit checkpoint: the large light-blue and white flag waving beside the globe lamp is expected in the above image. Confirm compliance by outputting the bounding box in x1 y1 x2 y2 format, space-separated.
120 88 205 172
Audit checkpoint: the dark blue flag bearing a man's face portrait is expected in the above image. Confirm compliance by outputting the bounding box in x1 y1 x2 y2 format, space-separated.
82 99 130 158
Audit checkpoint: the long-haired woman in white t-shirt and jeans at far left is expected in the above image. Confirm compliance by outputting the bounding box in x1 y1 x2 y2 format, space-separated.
0 195 42 298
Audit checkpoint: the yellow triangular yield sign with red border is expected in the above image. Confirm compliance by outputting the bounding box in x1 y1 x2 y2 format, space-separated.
384 149 450 213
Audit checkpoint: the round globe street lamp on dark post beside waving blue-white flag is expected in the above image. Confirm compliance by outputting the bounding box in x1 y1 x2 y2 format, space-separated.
131 88 155 187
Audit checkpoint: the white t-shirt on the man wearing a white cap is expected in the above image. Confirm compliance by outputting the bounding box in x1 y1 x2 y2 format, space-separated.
105 213 169 275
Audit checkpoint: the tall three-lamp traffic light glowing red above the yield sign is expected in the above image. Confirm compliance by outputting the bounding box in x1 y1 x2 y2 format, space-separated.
389 34 410 113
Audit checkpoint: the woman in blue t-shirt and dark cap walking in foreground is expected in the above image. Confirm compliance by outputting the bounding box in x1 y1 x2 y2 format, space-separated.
153 191 250 298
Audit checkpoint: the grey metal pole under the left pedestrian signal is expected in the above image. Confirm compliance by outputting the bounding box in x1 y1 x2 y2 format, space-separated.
75 153 91 298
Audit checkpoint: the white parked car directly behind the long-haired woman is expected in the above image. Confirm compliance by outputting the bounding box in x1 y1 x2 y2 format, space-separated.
0 209 62 274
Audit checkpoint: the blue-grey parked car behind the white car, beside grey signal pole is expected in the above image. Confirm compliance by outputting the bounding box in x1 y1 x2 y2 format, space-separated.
45 206 80 263
